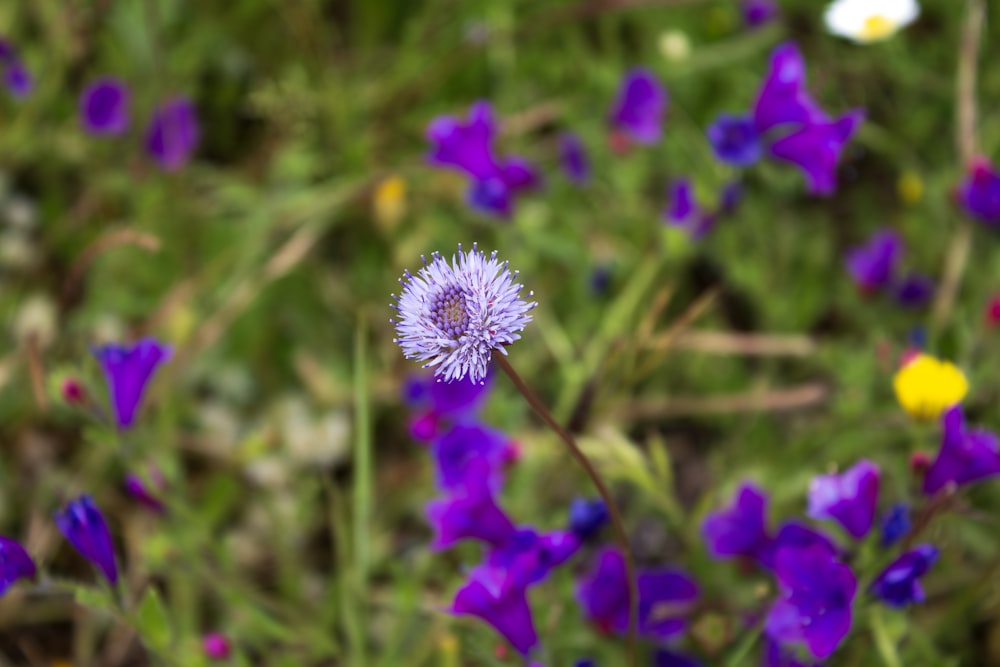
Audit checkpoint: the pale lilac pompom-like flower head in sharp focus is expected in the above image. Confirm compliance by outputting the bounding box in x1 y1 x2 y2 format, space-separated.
393 245 538 382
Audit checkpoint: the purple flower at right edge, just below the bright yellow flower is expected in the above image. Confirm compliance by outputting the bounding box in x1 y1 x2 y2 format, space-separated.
924 405 1000 495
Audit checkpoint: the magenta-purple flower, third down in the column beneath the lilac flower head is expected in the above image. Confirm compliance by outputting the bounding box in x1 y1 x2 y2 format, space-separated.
427 459 514 549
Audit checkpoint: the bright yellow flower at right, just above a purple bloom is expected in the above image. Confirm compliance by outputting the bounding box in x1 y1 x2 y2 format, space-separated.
892 354 969 420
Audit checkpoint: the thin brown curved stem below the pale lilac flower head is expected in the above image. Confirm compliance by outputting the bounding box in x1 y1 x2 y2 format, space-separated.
493 350 639 666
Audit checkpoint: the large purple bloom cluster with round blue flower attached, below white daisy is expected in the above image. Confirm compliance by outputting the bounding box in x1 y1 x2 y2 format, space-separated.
708 42 864 195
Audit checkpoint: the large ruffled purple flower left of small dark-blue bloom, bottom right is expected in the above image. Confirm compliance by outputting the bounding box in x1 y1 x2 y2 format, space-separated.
765 546 858 659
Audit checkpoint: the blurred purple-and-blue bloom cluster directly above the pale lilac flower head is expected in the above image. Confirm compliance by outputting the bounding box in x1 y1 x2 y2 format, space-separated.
427 102 540 218
